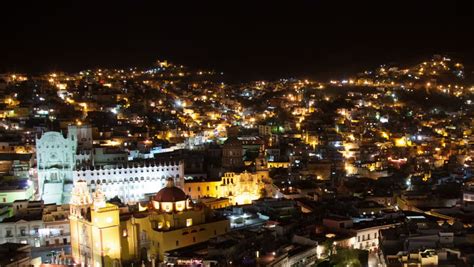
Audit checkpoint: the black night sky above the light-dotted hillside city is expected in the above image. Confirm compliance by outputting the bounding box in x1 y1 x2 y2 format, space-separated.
0 0 474 78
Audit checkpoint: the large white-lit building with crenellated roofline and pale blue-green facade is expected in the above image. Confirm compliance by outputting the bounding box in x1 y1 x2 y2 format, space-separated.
37 131 184 204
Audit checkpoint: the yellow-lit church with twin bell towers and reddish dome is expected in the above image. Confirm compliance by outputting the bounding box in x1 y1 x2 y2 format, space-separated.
70 179 230 266
